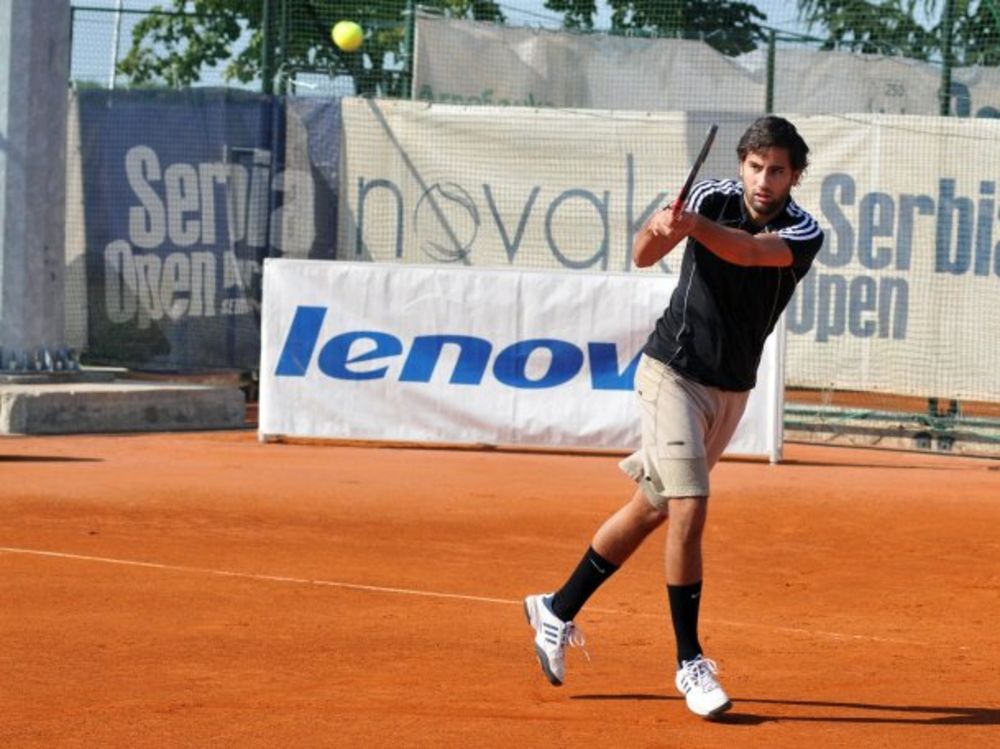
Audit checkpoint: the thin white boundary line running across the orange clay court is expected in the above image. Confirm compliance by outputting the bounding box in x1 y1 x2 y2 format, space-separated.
0 546 944 650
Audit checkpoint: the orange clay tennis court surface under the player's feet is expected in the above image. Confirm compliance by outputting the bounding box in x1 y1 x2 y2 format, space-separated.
0 431 1000 749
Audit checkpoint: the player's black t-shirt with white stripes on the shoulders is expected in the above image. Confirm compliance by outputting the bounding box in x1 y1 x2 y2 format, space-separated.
644 180 823 391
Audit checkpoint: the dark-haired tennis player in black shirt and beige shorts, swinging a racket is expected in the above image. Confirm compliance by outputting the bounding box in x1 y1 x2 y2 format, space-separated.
524 117 823 718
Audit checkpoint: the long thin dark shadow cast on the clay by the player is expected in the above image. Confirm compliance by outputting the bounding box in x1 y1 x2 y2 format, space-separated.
570 693 1000 726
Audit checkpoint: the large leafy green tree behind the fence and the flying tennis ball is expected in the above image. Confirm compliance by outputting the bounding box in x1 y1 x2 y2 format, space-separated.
118 0 503 94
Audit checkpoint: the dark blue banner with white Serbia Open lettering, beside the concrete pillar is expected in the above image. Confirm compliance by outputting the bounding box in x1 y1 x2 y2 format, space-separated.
79 89 284 371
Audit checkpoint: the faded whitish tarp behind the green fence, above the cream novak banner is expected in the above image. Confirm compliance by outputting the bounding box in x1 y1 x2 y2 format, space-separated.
413 14 1000 117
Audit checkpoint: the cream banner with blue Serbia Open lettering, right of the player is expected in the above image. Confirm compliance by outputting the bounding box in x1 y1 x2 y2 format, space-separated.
787 115 1000 402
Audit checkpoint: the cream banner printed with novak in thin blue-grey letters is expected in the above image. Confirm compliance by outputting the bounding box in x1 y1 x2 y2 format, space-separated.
337 98 751 271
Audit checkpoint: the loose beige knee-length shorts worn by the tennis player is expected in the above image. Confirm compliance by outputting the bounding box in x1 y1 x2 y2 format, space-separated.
619 354 750 509
